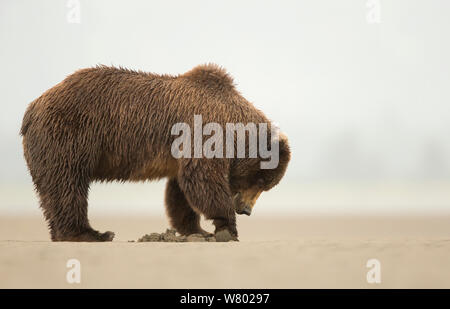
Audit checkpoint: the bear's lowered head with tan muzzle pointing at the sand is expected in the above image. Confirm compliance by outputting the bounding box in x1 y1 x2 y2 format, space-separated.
230 134 291 216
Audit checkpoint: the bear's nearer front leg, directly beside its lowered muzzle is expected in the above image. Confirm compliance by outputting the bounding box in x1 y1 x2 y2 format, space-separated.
178 158 238 241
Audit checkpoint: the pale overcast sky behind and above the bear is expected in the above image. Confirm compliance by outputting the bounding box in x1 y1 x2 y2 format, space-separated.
0 0 450 212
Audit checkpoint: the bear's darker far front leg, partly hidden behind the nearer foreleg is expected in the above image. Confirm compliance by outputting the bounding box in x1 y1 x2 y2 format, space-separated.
165 178 212 236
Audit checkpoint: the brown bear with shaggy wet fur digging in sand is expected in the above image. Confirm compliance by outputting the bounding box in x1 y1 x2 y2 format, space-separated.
20 64 290 241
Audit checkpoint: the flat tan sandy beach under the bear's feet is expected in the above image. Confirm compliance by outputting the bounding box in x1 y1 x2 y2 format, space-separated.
0 216 450 288
